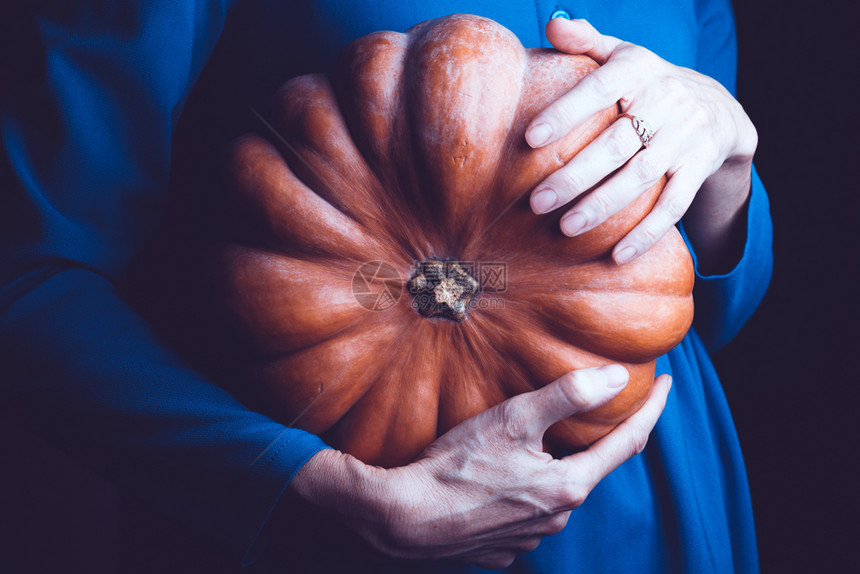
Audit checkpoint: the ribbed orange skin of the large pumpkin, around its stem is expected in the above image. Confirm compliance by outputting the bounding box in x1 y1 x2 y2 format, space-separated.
218 15 693 466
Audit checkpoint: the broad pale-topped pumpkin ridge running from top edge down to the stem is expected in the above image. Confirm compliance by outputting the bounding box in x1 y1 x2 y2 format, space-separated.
404 15 526 259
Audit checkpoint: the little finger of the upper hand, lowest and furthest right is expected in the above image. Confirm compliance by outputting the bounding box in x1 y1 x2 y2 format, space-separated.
612 168 707 265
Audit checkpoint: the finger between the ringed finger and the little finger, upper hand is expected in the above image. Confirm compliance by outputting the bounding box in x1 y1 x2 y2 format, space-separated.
560 141 676 237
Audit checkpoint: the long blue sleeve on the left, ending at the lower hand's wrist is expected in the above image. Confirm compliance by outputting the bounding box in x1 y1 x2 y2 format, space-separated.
0 1 325 563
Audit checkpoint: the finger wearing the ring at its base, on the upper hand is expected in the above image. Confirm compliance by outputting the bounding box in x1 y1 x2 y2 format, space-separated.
531 118 642 213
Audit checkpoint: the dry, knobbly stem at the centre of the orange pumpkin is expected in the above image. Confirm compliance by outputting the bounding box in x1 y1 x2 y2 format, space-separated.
408 259 480 321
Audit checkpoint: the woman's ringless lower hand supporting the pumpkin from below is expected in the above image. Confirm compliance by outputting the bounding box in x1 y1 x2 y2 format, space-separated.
291 365 671 568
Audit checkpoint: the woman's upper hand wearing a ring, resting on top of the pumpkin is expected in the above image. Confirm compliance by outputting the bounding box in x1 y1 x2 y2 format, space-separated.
526 18 757 270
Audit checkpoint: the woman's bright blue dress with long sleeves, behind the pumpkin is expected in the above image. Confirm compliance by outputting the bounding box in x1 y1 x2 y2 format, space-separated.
0 0 772 573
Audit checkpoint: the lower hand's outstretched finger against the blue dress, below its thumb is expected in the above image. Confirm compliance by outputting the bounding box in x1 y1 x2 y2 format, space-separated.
562 375 672 492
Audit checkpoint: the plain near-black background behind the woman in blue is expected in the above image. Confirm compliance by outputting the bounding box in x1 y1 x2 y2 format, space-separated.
0 0 860 573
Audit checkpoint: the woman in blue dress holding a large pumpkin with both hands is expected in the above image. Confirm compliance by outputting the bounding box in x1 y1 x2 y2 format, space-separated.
0 0 771 572
